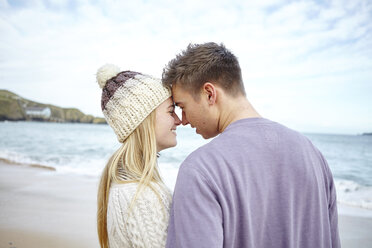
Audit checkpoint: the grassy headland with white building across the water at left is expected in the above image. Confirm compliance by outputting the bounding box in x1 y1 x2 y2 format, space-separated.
0 90 106 124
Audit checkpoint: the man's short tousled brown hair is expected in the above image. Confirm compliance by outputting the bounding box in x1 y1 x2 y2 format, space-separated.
162 42 245 99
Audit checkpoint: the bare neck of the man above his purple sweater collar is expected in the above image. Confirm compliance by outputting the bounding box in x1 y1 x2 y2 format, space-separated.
218 96 261 133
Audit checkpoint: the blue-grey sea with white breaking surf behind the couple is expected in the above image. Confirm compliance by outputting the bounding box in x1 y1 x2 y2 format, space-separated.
0 121 372 216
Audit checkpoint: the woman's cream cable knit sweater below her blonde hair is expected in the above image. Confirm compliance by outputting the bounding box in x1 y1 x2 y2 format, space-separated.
107 183 171 248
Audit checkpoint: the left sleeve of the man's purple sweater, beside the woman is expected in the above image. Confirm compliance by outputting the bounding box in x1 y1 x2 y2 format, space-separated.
166 164 223 248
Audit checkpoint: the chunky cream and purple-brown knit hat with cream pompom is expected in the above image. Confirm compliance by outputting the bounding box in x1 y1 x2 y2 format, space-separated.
97 64 171 143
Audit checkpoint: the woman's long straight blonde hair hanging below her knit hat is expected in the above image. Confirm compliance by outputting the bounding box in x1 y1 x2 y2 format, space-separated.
97 110 163 248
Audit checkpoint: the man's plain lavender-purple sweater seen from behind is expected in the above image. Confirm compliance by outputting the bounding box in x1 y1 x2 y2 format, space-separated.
167 118 340 248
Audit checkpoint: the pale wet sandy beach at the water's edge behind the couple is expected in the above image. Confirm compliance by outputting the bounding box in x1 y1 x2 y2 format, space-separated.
0 162 372 248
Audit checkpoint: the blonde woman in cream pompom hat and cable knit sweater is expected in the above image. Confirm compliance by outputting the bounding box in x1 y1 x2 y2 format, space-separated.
97 65 180 248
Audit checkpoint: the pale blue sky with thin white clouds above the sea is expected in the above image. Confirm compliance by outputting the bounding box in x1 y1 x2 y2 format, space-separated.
0 0 372 134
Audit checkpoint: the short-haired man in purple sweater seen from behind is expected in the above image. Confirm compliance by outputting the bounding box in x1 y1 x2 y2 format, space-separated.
163 43 340 248
